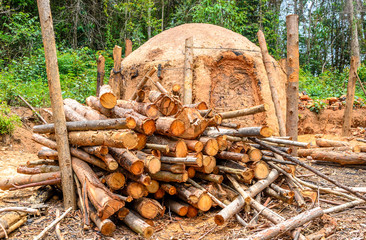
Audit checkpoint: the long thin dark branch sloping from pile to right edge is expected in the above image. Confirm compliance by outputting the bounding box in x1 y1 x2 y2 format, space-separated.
249 138 366 201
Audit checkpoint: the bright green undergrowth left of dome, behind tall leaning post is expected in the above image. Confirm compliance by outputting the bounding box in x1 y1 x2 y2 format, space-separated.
0 48 113 107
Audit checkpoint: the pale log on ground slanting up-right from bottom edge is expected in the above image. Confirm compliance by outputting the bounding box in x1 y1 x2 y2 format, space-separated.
239 207 324 240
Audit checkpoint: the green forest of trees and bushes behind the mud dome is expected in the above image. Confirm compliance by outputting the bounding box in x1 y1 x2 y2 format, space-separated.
0 0 366 107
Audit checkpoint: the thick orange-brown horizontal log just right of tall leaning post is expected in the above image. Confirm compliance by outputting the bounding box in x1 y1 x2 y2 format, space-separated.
69 129 138 149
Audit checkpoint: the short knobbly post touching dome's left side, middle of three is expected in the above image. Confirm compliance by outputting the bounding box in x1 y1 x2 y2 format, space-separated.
109 45 122 99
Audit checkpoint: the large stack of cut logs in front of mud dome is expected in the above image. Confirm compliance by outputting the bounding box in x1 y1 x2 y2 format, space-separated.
0 82 360 239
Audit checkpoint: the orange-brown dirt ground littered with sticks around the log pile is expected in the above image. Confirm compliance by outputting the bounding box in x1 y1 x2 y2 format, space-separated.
0 108 366 240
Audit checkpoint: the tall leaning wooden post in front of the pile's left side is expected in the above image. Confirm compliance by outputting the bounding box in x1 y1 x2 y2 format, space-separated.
37 0 76 209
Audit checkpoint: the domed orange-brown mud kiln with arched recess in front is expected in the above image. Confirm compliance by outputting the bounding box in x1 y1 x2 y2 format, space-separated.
121 23 286 135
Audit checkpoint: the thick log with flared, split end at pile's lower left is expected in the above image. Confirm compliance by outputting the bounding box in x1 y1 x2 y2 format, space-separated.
72 158 124 220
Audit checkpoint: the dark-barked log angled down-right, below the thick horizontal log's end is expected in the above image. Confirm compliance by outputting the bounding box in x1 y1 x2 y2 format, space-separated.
109 147 144 175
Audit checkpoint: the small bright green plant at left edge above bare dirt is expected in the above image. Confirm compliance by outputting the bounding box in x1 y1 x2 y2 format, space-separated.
0 102 21 135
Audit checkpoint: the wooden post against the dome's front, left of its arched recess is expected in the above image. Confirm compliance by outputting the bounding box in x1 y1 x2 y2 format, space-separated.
183 37 193 105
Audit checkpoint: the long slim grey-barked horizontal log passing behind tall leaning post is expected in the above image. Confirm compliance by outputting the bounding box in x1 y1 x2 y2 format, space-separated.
33 117 136 133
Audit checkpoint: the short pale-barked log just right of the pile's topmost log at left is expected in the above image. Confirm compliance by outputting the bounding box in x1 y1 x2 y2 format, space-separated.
117 100 159 119
